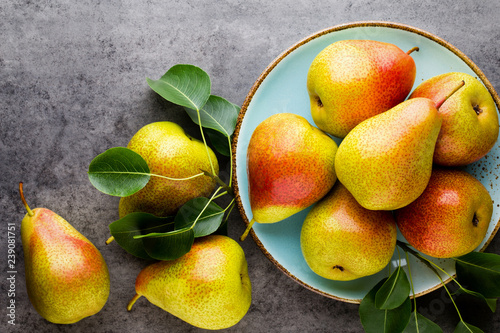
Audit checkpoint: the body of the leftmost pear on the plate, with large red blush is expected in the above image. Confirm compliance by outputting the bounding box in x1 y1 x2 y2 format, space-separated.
247 113 338 223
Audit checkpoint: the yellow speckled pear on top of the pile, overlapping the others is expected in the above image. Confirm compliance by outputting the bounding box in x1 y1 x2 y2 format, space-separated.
335 98 442 210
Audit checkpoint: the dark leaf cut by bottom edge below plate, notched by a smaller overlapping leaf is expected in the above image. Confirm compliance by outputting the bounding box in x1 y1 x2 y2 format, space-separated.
359 278 411 333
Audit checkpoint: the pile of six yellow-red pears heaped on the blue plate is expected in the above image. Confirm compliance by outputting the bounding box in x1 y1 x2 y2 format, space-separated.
242 40 499 281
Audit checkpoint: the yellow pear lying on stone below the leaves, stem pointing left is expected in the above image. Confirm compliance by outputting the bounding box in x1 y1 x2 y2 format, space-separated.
128 235 252 330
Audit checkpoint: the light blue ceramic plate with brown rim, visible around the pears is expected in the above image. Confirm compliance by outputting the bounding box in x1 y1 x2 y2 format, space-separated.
233 22 500 303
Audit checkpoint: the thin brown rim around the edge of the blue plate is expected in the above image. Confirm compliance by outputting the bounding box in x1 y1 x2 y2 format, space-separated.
231 21 500 304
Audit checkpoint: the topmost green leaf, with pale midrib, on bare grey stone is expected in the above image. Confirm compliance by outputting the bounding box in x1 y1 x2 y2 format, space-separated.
146 65 211 110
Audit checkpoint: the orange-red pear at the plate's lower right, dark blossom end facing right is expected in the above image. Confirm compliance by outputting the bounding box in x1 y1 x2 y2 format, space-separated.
395 169 493 258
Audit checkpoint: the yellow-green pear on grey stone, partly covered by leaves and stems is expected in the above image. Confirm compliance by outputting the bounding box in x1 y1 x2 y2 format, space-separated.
119 121 219 218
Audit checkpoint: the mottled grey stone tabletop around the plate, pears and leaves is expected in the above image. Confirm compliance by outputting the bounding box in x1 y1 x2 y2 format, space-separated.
0 0 500 332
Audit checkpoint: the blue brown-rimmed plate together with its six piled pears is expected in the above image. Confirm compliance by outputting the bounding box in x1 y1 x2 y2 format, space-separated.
233 22 500 303
